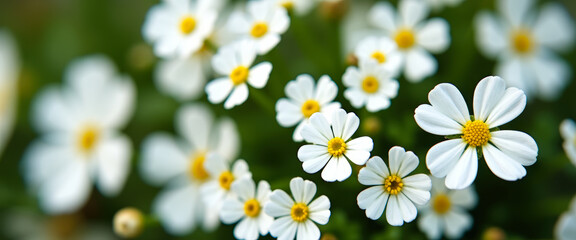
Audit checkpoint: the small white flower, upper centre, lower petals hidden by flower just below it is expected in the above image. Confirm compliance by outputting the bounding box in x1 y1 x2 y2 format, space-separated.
354 36 402 76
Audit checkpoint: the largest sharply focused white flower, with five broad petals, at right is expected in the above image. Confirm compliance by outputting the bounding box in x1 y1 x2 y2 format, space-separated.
414 77 538 189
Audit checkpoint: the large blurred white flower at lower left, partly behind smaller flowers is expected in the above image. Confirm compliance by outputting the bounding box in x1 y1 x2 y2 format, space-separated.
140 104 240 235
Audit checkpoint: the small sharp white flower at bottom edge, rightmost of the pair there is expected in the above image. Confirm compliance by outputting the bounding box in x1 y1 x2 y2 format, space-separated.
264 177 330 240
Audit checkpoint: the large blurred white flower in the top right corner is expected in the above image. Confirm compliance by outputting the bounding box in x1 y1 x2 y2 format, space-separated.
476 0 574 100
